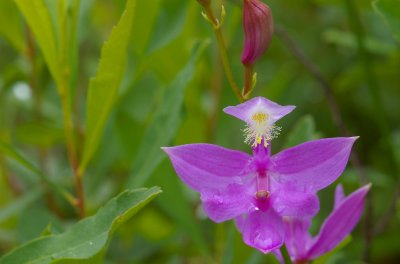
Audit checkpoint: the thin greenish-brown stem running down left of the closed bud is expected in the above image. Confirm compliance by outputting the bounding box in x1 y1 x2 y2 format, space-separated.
199 1 244 102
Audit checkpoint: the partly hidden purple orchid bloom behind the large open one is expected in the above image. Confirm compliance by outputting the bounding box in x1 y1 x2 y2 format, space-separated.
284 184 371 264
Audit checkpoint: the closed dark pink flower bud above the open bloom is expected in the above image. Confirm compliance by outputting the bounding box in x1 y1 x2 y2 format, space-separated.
242 0 274 65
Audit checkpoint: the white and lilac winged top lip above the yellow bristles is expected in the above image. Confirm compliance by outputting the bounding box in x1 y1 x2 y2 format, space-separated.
223 97 295 123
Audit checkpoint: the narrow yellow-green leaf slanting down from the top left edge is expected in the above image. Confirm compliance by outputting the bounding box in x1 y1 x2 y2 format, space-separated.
14 0 65 86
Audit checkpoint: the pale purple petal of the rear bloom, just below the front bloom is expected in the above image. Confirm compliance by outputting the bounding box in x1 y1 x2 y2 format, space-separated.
283 217 311 260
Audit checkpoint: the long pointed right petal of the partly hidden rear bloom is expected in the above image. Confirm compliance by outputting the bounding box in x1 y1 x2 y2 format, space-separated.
308 184 371 259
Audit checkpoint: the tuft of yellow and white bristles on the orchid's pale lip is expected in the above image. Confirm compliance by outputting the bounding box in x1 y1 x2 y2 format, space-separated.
244 111 281 147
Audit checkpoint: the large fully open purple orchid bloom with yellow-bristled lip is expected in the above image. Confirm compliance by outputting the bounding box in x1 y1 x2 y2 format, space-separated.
163 97 356 253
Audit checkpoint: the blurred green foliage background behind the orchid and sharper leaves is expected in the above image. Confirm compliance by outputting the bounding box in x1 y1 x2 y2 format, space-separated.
0 0 400 264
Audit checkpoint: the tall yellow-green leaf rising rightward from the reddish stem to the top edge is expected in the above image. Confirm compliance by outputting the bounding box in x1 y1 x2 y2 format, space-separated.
80 0 135 172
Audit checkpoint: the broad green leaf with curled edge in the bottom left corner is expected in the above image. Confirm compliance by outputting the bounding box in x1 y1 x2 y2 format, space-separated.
0 187 161 264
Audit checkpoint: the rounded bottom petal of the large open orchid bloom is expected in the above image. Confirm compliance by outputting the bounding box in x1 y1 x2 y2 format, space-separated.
243 209 284 254
